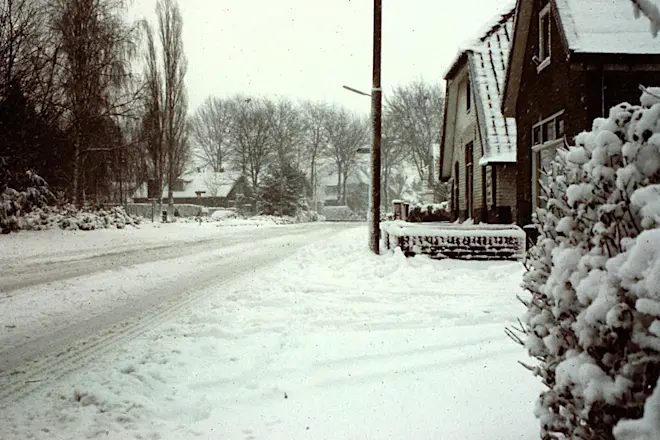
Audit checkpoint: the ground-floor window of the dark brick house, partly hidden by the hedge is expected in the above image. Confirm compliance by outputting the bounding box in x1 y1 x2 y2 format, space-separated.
532 110 564 208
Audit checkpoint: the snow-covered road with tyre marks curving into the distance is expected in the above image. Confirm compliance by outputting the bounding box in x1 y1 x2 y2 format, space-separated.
0 223 356 407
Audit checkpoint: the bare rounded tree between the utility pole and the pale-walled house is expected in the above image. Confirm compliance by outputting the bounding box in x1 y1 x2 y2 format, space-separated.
384 80 444 182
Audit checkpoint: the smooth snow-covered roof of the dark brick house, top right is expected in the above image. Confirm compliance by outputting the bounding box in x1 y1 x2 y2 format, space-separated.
555 0 660 55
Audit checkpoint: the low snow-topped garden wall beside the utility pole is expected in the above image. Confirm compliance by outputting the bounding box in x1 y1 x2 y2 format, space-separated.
380 220 525 260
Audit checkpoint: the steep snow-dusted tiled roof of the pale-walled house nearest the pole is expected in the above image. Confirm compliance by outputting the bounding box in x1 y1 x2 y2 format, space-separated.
468 10 516 165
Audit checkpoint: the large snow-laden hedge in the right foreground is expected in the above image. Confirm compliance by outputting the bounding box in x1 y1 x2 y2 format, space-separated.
508 92 660 440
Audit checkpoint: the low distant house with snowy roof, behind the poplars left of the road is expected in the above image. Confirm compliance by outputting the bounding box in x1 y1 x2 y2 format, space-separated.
133 168 251 208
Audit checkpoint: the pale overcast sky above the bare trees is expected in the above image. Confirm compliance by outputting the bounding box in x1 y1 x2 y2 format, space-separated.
134 0 511 113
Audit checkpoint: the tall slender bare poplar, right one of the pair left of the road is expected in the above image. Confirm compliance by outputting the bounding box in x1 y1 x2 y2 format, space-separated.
156 0 190 213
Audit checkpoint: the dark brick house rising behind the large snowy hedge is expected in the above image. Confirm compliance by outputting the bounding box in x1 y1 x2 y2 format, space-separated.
502 0 660 225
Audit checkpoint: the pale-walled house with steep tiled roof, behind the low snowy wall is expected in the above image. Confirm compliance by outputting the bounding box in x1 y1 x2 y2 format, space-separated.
439 8 516 223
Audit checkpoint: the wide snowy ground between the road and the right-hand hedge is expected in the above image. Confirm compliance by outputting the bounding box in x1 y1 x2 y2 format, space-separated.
0 228 540 440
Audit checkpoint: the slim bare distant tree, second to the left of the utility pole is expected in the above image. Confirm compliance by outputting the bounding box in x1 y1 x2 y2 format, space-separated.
302 101 329 209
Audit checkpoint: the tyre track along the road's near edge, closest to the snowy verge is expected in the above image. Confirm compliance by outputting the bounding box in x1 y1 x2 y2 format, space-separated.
0 227 350 408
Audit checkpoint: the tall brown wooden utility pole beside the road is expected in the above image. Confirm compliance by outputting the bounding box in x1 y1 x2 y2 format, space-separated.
369 0 383 254
